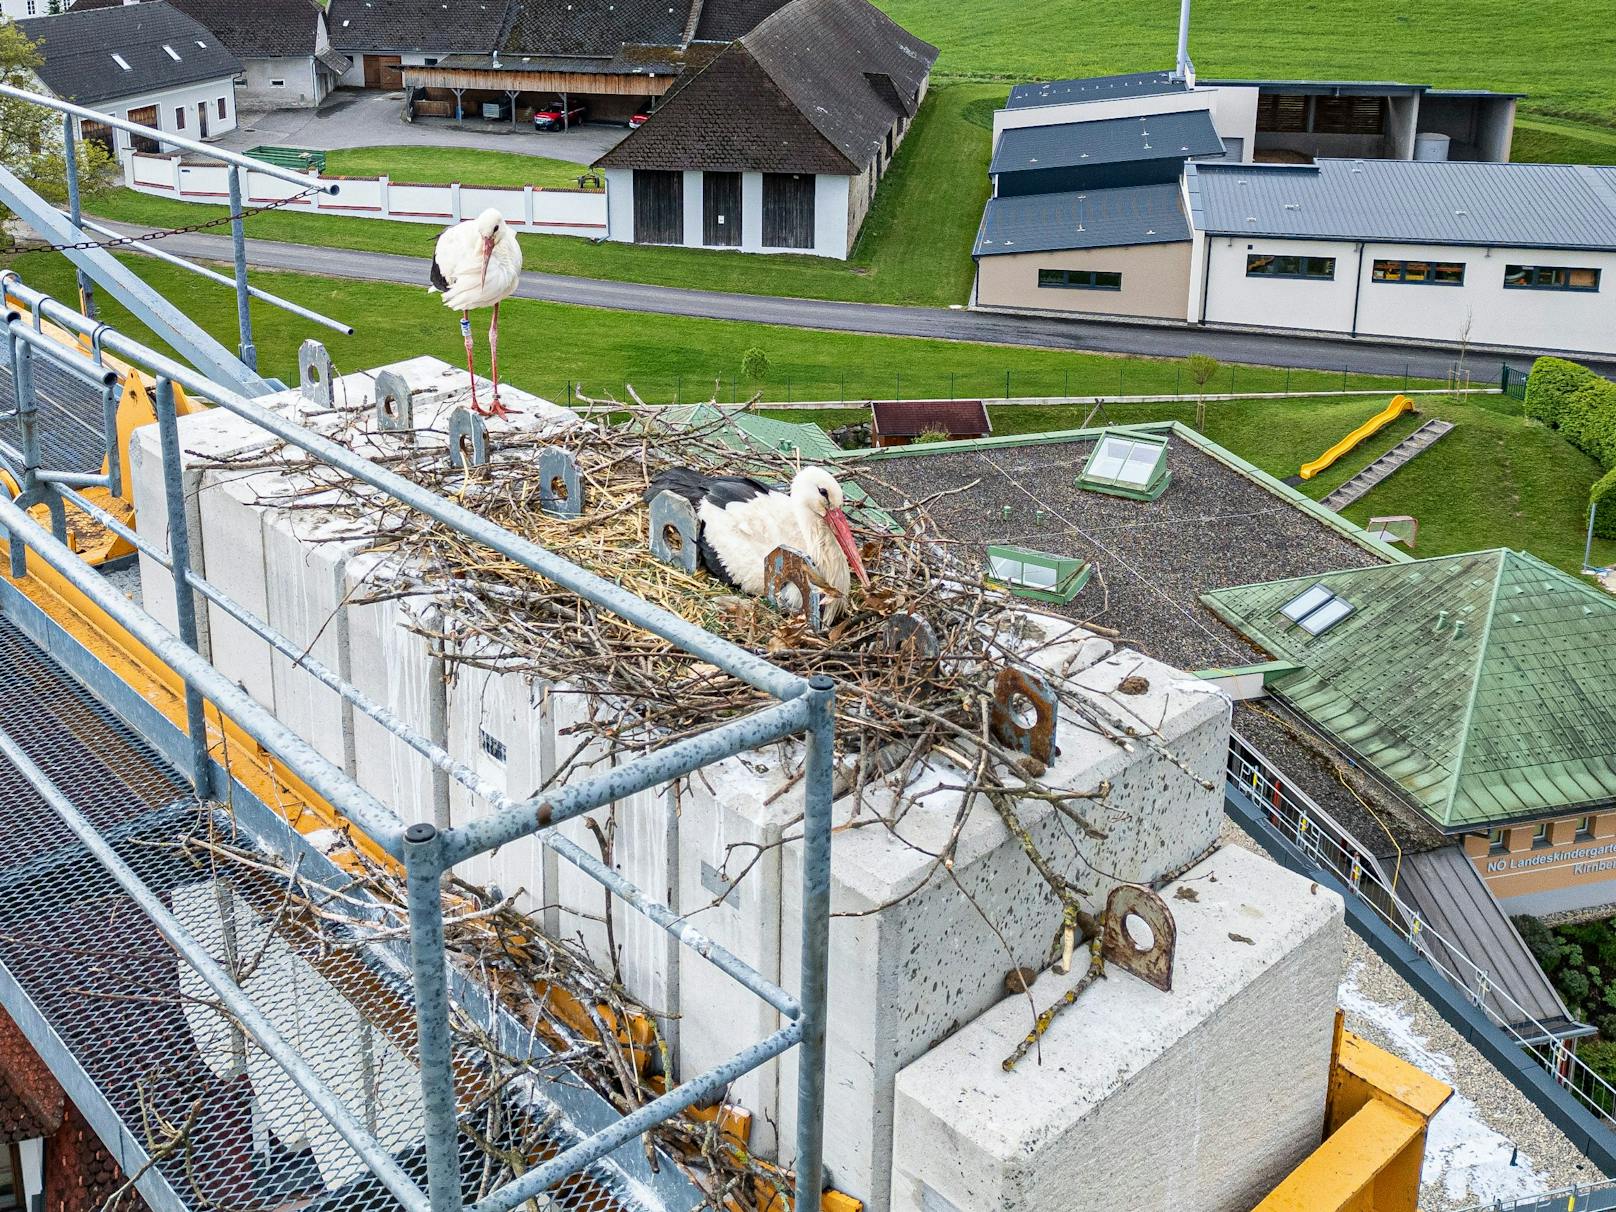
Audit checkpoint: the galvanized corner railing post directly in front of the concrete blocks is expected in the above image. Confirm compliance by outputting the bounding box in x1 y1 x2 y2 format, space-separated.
797 675 835 1212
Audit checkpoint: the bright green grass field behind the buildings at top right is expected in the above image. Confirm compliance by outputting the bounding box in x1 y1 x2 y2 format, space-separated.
876 0 1616 123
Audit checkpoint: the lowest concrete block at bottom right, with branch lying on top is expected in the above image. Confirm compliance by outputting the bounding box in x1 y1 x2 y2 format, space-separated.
890 847 1343 1212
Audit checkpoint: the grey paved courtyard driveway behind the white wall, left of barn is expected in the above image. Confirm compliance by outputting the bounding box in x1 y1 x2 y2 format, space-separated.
218 89 629 165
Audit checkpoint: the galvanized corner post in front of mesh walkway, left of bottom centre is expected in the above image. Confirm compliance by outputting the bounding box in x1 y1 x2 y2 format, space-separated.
404 821 462 1212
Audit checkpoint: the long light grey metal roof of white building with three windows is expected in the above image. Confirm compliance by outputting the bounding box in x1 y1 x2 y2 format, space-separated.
1185 160 1616 250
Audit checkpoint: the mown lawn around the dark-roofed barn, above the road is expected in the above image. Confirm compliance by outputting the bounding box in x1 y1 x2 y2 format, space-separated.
87 84 1004 307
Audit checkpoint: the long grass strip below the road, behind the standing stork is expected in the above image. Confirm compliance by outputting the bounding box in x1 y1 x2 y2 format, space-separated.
0 254 1403 402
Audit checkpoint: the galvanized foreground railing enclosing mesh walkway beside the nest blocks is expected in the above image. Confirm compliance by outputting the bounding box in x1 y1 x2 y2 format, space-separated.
0 273 834 1212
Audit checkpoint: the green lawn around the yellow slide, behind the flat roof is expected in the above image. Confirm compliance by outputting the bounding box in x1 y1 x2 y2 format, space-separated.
769 396 1616 572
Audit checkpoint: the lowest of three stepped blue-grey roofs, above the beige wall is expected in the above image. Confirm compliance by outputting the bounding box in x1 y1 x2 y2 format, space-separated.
971 184 1189 257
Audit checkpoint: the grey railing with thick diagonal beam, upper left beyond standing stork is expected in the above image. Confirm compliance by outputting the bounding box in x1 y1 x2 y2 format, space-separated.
0 84 352 394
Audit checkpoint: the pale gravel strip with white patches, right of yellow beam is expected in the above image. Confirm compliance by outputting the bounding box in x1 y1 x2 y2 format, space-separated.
1222 821 1603 1212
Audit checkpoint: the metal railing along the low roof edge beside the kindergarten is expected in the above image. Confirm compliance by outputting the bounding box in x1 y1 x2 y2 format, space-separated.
1225 734 1616 1126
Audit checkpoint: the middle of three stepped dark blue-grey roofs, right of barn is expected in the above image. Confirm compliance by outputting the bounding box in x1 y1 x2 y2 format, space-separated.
987 110 1223 173
